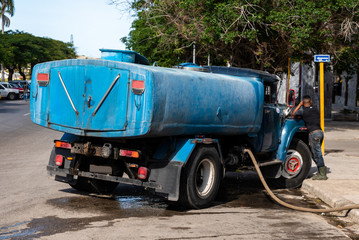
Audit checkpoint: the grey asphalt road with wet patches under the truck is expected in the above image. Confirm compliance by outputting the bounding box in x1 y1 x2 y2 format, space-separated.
0 100 354 240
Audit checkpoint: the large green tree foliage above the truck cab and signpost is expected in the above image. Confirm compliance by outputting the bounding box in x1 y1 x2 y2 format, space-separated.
116 0 359 73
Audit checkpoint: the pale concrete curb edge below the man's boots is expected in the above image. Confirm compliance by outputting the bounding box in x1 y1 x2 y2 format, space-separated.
301 180 359 223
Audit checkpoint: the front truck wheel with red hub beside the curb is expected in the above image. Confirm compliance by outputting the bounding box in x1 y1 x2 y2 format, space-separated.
268 138 312 188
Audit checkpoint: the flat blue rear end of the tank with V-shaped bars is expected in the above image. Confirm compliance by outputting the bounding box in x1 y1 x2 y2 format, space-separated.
30 60 152 137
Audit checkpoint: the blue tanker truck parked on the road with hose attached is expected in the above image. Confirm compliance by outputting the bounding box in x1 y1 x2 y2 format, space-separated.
30 49 312 208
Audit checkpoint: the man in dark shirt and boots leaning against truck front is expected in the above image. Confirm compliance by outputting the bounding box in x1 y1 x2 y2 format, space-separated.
292 95 328 180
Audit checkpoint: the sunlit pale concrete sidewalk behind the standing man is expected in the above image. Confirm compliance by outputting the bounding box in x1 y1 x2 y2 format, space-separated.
302 121 359 223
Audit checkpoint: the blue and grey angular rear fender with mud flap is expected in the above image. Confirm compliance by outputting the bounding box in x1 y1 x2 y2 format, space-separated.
148 138 223 201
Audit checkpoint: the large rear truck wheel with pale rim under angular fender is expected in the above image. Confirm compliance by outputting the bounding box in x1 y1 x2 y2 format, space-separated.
179 146 223 208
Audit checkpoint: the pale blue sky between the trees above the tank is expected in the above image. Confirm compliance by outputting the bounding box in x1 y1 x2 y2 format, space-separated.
5 0 132 58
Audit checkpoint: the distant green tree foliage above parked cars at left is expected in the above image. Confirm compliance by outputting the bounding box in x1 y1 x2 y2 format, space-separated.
0 31 76 77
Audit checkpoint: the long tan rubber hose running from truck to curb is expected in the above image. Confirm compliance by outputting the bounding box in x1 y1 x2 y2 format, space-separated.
244 149 359 213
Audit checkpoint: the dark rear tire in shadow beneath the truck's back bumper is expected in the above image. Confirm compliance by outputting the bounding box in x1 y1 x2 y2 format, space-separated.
69 177 118 194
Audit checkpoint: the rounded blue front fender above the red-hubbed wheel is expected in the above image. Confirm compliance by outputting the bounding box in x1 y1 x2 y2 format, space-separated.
276 119 305 162
